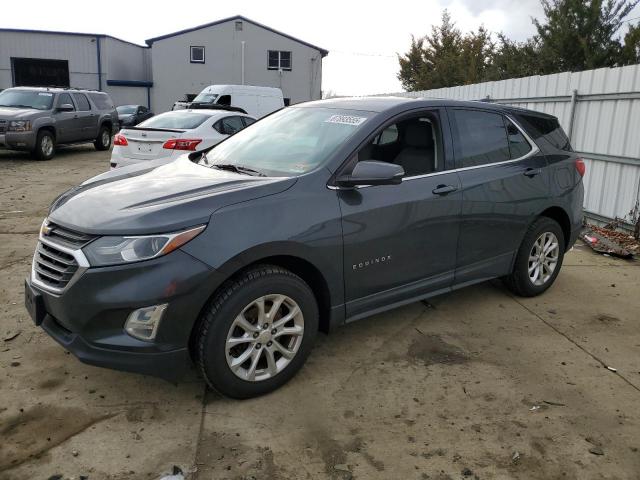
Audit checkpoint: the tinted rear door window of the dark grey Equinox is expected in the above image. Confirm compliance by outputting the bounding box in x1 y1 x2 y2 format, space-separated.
453 109 511 168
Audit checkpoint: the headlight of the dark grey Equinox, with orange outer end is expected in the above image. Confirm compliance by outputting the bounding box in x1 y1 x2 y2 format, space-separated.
83 225 206 267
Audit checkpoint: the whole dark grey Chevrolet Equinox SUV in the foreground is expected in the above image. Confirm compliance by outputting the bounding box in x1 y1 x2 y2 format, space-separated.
26 97 585 398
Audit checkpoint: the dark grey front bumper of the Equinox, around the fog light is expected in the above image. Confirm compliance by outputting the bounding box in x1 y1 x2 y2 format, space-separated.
27 250 219 382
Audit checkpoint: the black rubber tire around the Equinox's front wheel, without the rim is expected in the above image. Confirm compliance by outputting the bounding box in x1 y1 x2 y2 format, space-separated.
195 265 319 398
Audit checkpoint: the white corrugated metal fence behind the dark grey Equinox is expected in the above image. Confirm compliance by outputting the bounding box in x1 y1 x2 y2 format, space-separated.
380 65 640 226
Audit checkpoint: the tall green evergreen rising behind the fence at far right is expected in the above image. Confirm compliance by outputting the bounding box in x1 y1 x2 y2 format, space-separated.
533 0 639 73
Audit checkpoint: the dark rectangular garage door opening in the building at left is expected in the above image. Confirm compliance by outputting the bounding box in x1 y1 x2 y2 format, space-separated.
11 57 69 87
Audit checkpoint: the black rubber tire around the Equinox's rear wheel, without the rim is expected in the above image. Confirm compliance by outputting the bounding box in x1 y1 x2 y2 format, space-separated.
503 217 565 297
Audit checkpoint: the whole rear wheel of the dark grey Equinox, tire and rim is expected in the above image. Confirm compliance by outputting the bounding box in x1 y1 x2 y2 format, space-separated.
504 217 564 297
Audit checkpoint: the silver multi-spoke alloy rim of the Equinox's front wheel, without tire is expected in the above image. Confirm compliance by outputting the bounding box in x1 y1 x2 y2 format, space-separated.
225 294 304 382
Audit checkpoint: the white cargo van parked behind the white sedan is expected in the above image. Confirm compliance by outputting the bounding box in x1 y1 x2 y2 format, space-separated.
172 85 284 118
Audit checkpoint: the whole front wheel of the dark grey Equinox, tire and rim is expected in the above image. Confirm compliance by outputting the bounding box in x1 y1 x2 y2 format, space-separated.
196 265 318 398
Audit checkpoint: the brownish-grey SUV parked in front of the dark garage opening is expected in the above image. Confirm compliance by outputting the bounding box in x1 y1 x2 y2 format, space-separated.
0 87 118 160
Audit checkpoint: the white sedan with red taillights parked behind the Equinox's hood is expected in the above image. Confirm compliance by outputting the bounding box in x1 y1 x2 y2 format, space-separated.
111 110 256 168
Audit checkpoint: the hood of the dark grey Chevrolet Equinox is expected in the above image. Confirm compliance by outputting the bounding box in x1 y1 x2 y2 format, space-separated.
49 155 296 235
